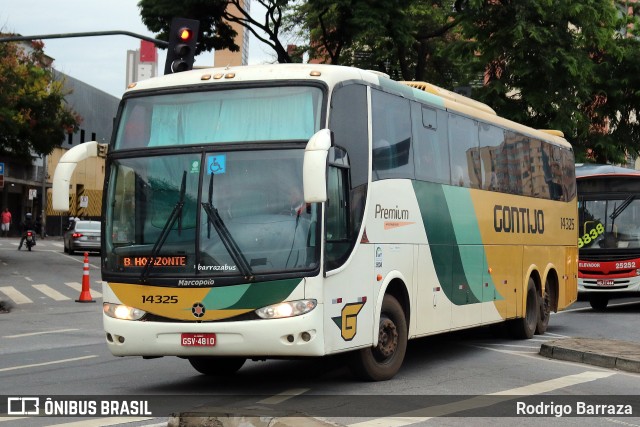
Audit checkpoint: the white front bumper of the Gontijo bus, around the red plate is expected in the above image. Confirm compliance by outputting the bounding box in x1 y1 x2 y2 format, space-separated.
103 305 324 358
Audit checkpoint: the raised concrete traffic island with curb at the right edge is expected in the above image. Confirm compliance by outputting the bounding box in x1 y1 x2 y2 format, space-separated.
540 338 640 373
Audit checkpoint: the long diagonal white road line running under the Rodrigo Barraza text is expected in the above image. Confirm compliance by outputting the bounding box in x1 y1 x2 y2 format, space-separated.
349 371 615 427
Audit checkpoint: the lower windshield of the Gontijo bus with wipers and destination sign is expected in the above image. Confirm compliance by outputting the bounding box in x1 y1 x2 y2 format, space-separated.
105 148 319 279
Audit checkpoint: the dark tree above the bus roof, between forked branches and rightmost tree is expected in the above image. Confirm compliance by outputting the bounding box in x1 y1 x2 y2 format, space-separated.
290 0 458 85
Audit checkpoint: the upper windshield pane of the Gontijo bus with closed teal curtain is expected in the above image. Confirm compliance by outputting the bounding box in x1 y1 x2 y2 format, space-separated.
113 86 322 150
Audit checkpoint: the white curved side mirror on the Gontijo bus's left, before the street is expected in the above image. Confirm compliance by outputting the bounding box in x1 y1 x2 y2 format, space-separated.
51 141 98 211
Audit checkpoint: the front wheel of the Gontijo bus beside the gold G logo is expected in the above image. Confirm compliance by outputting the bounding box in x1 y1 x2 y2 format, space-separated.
349 295 408 381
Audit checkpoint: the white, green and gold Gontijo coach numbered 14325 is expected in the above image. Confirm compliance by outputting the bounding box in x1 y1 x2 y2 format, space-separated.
54 64 577 380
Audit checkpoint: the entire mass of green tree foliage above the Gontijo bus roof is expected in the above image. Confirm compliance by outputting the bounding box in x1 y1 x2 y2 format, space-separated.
138 0 640 163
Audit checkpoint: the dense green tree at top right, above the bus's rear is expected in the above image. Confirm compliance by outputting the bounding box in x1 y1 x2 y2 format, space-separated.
450 0 640 162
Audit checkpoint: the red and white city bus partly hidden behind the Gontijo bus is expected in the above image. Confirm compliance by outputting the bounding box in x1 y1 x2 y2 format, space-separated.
576 164 640 310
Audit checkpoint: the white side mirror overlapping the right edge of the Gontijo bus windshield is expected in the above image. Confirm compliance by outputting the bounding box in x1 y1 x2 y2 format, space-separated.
302 129 331 203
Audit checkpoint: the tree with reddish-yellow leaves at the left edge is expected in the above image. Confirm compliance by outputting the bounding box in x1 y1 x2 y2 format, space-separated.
0 42 81 162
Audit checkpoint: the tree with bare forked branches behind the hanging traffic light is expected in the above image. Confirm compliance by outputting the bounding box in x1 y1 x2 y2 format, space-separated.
138 0 292 62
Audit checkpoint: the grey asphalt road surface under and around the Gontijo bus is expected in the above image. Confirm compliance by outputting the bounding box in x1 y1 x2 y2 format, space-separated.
0 239 640 427
